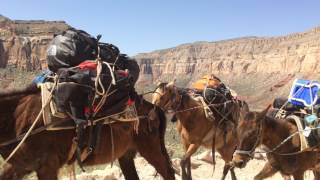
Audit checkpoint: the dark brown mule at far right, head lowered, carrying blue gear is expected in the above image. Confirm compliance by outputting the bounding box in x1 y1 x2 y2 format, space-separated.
233 106 320 180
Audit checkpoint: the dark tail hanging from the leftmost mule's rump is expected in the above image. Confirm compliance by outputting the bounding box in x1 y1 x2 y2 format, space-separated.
156 107 175 174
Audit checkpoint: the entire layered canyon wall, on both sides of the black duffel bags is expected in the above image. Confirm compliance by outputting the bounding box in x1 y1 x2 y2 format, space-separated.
0 15 320 108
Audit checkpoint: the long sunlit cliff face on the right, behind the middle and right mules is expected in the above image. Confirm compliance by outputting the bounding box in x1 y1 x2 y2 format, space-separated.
136 27 320 106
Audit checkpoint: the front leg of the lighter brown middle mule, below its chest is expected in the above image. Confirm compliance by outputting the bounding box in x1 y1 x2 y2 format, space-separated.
180 144 200 180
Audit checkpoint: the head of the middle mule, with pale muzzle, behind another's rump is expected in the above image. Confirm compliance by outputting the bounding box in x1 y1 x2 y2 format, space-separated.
152 81 181 110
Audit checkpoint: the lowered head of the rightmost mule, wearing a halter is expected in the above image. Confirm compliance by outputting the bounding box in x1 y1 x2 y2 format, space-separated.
232 106 270 168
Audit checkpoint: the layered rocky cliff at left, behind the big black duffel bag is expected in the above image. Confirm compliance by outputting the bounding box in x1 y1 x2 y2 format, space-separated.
0 15 69 71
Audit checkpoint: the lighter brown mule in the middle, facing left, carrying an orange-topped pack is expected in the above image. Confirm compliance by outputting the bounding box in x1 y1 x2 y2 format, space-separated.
152 82 249 180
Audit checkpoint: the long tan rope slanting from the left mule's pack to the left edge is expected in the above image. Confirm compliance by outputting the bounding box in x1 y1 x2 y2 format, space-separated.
1 76 58 169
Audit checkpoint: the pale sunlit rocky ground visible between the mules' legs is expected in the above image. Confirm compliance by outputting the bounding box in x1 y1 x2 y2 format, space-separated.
68 152 313 180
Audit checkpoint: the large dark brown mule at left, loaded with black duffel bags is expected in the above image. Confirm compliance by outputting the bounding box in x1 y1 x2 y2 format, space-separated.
0 85 175 180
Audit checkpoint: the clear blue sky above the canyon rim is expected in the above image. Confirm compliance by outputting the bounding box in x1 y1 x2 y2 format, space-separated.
0 0 320 55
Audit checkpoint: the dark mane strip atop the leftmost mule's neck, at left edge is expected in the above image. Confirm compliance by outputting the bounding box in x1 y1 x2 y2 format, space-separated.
0 84 40 98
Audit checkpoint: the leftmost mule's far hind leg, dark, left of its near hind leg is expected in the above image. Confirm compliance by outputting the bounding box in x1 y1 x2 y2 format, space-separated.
118 151 139 180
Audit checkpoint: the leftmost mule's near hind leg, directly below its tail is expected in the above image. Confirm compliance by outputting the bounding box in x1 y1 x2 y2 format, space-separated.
137 138 175 180
